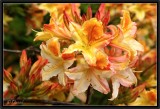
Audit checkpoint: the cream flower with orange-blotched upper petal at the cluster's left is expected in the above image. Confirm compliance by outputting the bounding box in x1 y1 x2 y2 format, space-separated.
40 38 74 86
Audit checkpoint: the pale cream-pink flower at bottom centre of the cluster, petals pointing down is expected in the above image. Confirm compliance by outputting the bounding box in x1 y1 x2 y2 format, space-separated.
65 57 110 95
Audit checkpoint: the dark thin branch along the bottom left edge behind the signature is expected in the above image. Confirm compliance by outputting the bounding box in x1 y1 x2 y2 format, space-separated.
3 99 78 105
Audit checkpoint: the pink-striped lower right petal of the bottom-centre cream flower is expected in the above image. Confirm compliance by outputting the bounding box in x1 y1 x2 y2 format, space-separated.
91 72 110 94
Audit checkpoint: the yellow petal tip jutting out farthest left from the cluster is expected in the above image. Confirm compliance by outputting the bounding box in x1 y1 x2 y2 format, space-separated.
34 32 53 41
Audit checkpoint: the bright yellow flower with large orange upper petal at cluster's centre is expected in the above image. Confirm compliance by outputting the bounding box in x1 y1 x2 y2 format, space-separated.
64 18 110 69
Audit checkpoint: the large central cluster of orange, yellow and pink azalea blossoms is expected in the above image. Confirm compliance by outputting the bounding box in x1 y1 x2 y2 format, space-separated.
34 4 144 100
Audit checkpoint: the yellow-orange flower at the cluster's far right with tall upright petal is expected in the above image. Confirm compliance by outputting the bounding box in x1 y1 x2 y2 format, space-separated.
110 10 144 60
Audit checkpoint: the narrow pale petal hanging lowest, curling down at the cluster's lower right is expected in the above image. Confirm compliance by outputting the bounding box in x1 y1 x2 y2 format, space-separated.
109 78 120 101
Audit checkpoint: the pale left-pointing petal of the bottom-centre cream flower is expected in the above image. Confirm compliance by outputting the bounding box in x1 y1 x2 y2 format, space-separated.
65 72 83 80
